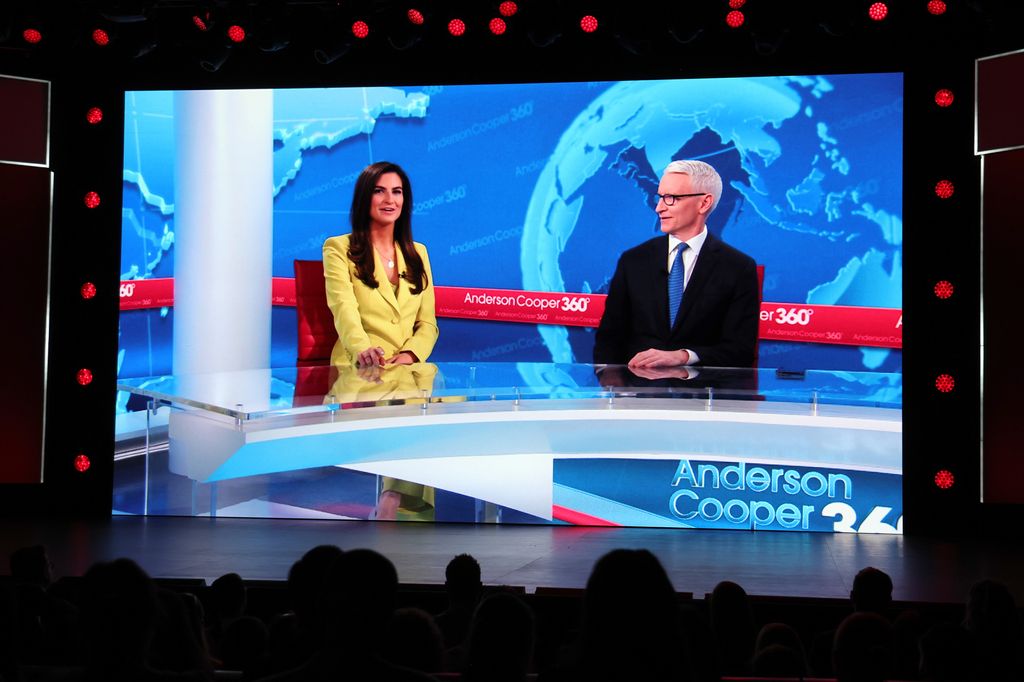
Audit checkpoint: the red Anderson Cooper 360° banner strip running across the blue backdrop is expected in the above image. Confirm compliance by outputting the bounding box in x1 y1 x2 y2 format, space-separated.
121 278 903 348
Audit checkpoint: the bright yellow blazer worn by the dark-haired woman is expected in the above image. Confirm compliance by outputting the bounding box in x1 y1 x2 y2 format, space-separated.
324 235 437 365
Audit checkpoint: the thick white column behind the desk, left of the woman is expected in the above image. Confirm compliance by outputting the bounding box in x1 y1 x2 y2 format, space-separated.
173 90 273 376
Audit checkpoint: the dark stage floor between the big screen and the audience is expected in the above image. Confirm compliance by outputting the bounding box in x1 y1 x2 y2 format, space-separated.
0 516 1024 604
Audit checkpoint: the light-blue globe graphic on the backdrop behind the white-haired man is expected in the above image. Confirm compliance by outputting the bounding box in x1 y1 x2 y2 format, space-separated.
520 77 902 385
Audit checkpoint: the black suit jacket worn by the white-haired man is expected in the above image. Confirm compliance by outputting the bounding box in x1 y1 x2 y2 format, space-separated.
594 232 761 367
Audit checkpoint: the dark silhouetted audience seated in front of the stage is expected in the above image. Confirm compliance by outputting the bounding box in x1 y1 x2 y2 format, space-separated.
0 545 1024 682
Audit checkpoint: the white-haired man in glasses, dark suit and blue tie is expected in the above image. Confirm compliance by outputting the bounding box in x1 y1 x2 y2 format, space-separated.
594 161 760 369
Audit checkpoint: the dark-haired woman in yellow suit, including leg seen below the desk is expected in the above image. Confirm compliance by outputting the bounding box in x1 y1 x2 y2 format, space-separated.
324 161 437 520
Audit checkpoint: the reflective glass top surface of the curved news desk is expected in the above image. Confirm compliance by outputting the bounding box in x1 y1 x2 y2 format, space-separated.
118 363 903 420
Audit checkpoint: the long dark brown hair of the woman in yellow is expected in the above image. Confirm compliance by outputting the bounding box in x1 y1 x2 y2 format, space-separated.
348 161 429 294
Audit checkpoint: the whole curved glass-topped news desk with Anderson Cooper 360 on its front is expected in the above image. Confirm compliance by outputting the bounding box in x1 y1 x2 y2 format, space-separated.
114 363 902 532
